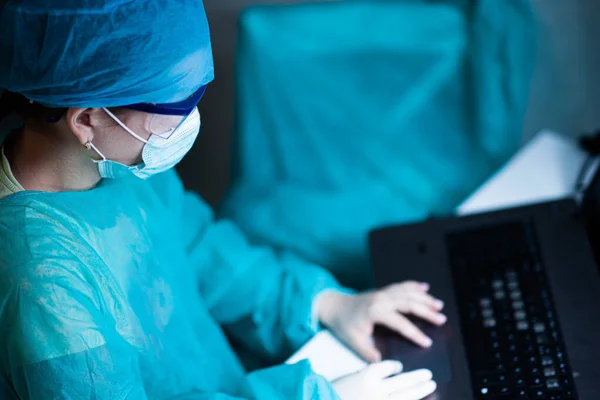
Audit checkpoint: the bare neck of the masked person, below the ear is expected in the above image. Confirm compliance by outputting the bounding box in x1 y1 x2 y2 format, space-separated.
5 126 100 192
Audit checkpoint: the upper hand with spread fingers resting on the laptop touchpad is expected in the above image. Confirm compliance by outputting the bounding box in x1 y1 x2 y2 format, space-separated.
318 281 446 362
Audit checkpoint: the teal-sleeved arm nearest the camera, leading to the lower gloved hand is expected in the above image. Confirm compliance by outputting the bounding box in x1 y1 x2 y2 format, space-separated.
0 259 337 400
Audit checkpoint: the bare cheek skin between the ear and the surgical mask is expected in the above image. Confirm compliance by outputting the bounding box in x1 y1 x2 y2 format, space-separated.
94 128 149 165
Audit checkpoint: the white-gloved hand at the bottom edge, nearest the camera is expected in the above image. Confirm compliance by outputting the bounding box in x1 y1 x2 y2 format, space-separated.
333 361 437 400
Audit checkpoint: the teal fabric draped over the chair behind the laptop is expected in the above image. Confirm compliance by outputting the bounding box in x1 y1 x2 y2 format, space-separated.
221 0 533 287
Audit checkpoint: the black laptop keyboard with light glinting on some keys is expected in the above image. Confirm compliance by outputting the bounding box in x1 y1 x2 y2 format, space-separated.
447 222 577 400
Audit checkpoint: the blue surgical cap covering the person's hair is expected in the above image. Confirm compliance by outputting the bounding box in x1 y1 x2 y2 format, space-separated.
0 0 214 107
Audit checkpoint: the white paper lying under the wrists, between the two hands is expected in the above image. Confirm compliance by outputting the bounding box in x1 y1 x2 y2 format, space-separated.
286 331 367 382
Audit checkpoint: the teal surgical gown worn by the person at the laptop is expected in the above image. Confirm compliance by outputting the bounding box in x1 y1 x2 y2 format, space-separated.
0 171 337 400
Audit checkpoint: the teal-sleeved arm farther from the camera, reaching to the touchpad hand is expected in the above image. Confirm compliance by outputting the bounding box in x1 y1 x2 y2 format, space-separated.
183 188 339 361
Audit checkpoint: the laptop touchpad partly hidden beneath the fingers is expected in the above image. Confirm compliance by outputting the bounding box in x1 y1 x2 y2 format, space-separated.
375 317 452 383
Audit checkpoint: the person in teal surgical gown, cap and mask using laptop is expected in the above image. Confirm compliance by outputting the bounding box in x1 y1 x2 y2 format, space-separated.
0 0 445 400
